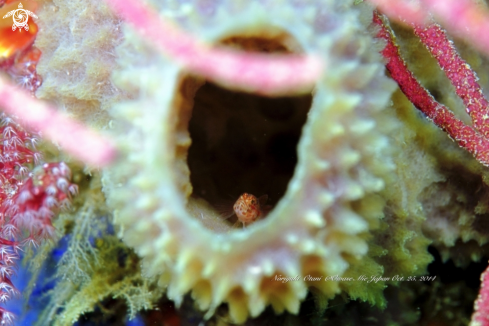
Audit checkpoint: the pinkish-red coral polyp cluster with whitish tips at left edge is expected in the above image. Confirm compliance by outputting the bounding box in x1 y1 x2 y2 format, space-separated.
0 115 78 325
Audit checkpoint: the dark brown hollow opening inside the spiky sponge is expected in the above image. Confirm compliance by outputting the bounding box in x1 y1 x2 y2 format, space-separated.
183 35 312 227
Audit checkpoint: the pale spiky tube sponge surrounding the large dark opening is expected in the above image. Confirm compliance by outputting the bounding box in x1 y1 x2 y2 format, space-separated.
104 1 393 322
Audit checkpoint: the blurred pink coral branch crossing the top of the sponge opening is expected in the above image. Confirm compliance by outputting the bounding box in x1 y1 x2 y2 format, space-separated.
106 0 324 95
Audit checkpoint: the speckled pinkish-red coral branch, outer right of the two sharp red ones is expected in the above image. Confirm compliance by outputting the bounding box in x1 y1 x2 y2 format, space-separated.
414 24 489 138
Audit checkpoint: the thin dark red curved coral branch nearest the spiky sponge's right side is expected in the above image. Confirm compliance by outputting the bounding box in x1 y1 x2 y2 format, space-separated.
373 12 489 166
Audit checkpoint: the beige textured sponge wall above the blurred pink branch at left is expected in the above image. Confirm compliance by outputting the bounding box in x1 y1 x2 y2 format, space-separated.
35 0 122 128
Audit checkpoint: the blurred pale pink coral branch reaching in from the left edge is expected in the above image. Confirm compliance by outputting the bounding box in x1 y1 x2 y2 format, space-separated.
0 78 117 166
